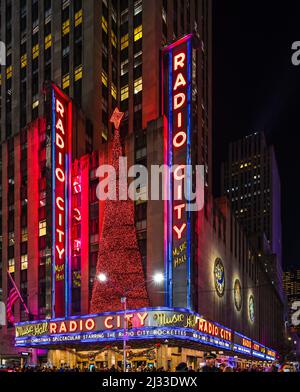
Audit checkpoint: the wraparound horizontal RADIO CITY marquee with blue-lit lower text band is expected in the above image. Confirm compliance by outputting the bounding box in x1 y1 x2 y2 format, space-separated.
15 308 276 360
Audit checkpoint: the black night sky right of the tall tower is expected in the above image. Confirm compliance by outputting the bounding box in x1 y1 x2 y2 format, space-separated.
213 0 300 268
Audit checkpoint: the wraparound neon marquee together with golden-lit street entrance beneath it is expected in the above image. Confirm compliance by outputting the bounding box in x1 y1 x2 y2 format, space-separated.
15 308 276 368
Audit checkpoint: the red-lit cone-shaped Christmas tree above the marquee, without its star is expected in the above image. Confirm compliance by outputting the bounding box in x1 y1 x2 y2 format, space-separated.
90 122 149 313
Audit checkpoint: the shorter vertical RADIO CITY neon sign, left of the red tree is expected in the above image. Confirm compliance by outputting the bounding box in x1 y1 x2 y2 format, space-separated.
51 85 72 317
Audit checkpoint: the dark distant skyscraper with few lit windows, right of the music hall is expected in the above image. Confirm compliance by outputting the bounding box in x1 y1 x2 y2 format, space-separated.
221 132 282 290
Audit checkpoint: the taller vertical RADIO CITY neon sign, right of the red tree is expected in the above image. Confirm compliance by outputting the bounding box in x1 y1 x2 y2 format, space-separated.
162 34 193 308
